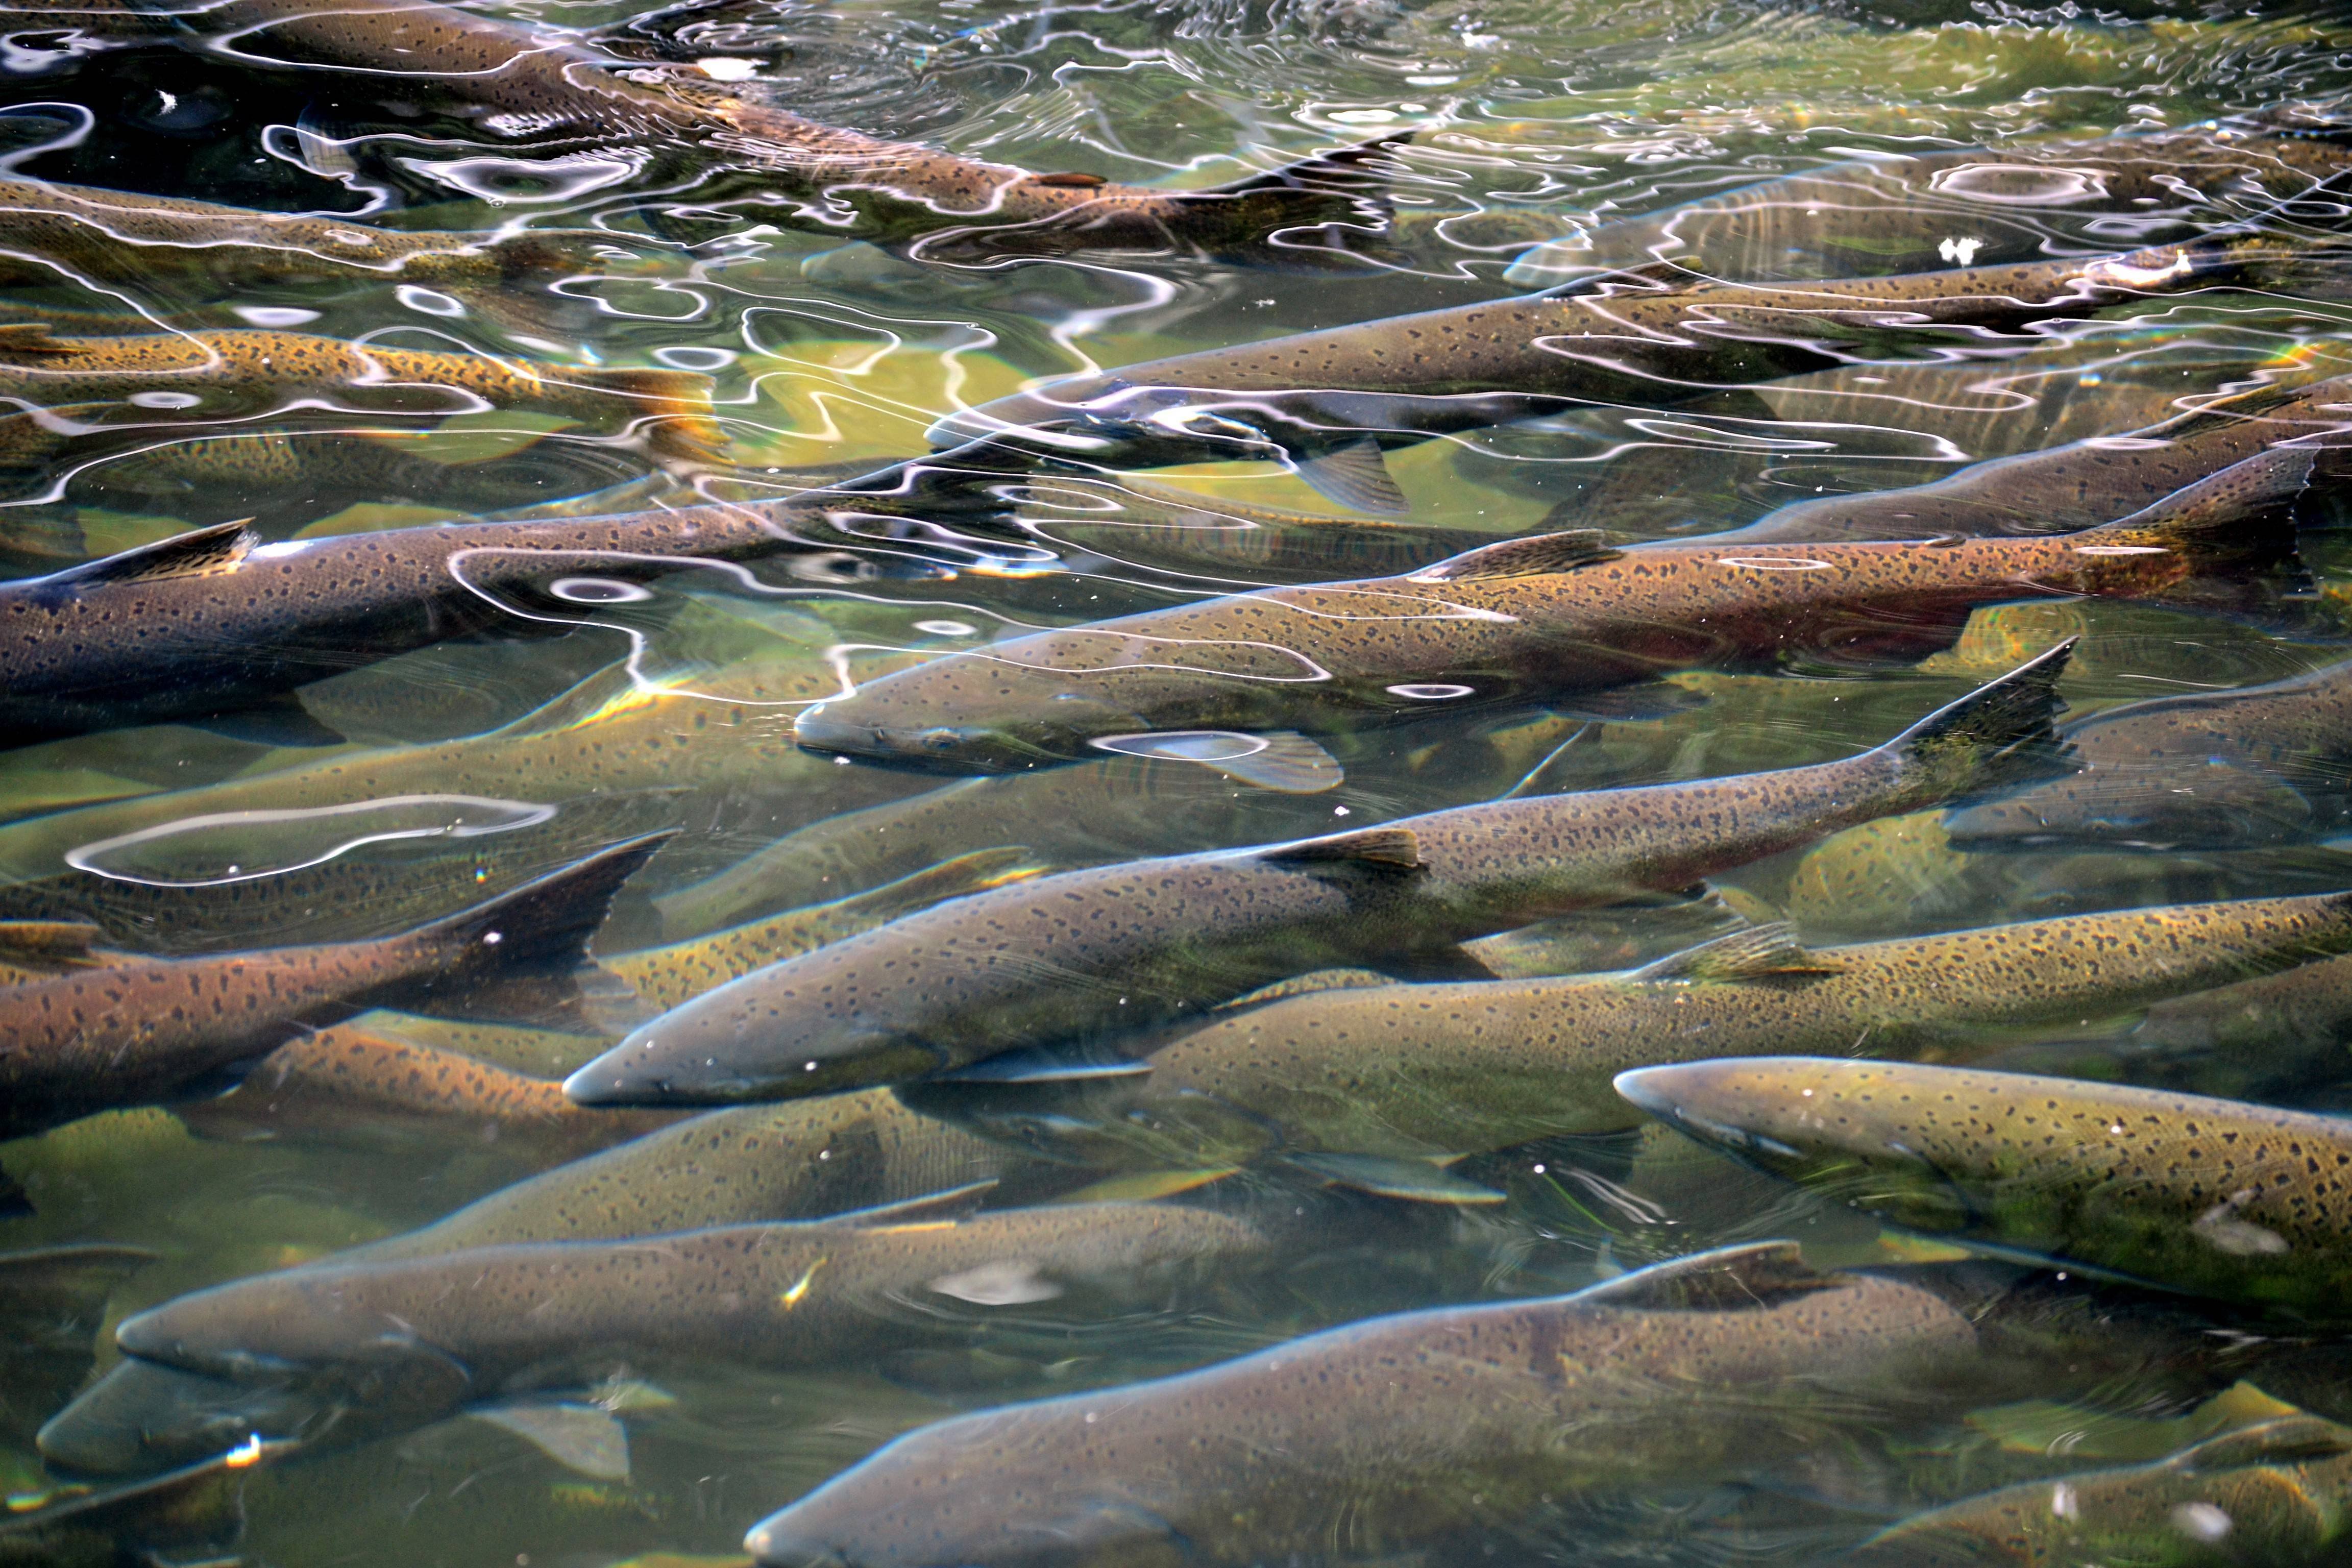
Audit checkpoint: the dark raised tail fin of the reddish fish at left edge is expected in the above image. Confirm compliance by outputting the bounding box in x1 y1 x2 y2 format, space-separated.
400 832 677 1020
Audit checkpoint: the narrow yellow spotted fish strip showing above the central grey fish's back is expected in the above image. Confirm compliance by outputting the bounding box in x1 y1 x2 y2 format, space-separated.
597 846 1040 1013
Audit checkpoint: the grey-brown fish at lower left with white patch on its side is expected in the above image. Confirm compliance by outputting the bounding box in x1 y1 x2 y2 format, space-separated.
115 1187 1268 1425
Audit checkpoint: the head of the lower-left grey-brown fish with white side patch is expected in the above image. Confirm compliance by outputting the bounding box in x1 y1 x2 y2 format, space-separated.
115 1265 475 1420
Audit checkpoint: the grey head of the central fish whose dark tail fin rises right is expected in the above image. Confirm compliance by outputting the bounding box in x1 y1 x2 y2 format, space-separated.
565 987 948 1105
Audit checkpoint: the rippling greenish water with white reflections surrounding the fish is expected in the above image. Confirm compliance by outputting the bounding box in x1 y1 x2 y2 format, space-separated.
0 0 2352 1568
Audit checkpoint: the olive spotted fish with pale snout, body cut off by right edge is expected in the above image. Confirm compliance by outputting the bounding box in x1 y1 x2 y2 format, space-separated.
1616 1056 2352 1321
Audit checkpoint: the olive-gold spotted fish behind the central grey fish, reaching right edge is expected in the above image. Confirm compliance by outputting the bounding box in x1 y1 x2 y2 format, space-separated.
917 893 2352 1202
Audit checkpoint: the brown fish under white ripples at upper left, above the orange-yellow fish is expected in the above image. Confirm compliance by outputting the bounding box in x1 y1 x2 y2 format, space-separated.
0 179 611 284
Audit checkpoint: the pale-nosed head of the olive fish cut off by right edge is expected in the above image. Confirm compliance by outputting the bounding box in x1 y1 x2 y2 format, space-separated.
1616 1056 1978 1232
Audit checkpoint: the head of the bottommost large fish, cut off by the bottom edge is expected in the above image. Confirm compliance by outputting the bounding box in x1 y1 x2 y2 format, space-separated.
743 1399 1190 1568
